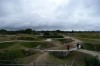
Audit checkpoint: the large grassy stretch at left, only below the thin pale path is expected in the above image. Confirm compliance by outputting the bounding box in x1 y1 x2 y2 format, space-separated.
0 42 54 63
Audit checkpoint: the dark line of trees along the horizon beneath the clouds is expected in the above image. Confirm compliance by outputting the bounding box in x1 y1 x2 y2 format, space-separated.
0 28 100 34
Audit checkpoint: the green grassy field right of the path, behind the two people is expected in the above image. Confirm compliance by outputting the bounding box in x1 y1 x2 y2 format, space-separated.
66 32 100 51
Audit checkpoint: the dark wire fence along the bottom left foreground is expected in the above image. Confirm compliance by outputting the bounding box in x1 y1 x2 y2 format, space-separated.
0 60 72 66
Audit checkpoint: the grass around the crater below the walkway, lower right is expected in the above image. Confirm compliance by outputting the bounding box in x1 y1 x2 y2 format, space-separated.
49 51 92 66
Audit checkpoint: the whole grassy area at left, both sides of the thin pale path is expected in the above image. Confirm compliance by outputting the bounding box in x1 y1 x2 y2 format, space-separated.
0 34 55 63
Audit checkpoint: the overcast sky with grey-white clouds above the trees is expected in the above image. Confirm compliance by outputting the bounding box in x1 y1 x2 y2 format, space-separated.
0 0 100 30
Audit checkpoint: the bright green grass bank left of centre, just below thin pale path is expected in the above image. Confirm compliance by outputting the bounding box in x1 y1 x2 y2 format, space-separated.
20 42 53 48
